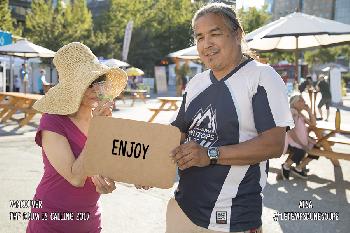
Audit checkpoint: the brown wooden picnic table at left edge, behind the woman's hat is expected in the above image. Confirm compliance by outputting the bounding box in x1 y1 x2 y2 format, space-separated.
0 92 42 127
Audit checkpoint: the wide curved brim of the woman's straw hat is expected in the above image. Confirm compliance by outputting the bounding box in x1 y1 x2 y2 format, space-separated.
33 64 127 115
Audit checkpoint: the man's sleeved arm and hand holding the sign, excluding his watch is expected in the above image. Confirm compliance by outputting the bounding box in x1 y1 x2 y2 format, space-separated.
172 67 294 169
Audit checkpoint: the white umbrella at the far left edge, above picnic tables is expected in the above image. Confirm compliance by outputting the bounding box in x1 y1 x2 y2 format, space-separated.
0 39 55 58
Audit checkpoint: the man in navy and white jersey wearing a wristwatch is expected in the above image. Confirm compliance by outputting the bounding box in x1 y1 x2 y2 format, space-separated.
167 3 293 233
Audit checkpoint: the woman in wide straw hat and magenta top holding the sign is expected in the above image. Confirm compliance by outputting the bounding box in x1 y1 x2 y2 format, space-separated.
27 42 127 233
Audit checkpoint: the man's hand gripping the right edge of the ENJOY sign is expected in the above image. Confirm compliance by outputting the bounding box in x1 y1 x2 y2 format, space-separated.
171 141 210 170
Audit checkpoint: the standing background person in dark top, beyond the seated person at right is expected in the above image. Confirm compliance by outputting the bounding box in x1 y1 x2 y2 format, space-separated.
316 74 332 121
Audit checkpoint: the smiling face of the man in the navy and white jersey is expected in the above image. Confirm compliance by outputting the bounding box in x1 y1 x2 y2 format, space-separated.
194 14 240 73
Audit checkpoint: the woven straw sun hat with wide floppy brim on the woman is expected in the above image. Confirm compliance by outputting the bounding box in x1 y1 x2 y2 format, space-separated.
33 42 127 115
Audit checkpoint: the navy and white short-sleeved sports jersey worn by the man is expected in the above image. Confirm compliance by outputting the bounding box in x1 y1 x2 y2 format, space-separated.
172 59 293 232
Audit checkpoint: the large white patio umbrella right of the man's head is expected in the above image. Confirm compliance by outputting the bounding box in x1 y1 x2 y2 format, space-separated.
246 12 350 51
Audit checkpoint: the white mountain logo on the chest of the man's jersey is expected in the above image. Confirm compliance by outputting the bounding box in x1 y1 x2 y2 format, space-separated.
187 105 218 147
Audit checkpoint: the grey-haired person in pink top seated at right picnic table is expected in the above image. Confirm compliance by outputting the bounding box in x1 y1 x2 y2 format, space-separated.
281 95 318 180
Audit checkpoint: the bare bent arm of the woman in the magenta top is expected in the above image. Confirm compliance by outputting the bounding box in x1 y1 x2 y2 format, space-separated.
42 130 87 187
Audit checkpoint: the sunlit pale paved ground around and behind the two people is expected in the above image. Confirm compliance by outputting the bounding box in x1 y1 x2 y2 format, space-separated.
0 92 350 233
